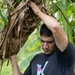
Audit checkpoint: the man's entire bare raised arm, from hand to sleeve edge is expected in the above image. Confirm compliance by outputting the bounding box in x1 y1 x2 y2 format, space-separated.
29 2 68 52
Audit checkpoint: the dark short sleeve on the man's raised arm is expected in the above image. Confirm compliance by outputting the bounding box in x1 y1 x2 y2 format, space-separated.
59 42 75 66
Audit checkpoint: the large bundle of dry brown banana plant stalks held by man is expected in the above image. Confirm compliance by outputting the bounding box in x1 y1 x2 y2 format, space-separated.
0 0 46 60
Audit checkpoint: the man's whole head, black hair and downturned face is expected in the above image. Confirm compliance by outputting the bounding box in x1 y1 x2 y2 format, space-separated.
40 24 56 54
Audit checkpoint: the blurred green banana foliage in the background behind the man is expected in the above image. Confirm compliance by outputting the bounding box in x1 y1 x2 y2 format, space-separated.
0 0 75 75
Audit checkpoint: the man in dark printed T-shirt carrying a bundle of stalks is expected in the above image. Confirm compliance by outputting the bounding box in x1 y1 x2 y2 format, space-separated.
11 2 75 75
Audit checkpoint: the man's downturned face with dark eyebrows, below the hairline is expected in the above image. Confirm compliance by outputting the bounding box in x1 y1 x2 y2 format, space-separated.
40 35 56 54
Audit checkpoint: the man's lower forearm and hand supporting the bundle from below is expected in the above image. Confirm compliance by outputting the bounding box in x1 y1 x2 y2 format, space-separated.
11 55 22 75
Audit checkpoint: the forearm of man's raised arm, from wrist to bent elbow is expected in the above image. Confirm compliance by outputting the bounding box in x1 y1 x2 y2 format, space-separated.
37 11 60 32
